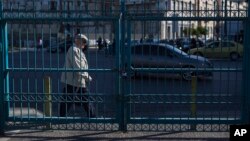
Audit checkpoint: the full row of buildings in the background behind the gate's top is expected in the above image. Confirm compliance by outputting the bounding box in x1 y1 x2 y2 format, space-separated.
4 0 246 47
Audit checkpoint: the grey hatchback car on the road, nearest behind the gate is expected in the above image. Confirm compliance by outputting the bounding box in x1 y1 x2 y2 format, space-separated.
131 43 213 80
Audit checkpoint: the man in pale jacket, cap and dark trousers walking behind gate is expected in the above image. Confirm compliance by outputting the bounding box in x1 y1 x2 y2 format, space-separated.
60 34 95 117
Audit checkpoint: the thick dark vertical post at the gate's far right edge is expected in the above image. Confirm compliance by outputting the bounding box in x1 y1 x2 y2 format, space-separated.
241 1 250 124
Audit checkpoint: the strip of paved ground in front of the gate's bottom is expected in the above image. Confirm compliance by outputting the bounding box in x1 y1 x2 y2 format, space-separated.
0 130 229 141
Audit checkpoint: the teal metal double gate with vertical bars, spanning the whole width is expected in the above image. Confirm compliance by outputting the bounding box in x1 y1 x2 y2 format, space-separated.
0 0 250 133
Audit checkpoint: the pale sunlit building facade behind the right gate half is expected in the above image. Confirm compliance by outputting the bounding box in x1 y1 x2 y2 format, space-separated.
127 0 246 39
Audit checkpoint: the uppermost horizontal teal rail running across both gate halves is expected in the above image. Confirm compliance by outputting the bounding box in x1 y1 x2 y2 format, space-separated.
2 11 247 22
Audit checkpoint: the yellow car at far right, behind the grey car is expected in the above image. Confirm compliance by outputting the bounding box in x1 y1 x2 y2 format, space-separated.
189 41 243 60
